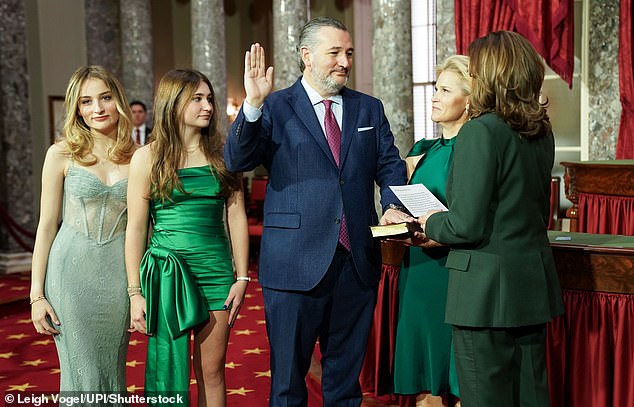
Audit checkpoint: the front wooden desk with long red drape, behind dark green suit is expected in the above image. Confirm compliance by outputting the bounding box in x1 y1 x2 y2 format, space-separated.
546 231 634 407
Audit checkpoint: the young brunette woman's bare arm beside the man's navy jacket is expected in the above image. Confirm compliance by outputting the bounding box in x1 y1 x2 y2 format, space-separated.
225 180 249 326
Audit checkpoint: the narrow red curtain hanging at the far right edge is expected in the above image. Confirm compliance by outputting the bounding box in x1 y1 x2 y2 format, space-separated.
616 0 634 159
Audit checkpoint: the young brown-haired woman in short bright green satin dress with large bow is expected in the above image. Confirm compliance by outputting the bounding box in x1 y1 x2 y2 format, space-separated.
125 69 249 406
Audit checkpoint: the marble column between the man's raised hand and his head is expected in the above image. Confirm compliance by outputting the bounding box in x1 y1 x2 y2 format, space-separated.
273 0 308 89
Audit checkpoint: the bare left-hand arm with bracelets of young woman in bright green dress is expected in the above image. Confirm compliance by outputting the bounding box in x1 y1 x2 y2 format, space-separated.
125 145 151 333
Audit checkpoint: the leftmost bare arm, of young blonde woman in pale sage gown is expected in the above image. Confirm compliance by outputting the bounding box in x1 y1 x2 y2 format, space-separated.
30 144 69 335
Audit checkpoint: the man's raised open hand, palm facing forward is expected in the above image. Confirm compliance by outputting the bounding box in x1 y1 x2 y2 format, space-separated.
244 43 273 108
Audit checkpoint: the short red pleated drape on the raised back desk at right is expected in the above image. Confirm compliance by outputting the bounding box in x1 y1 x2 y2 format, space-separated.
578 193 634 236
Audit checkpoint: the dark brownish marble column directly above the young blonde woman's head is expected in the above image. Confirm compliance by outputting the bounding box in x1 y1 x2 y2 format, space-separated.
84 0 121 78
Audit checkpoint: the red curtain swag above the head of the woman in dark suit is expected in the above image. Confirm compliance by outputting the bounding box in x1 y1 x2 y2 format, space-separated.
454 0 572 87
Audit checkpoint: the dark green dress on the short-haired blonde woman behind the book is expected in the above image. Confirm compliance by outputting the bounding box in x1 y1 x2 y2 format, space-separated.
394 138 459 396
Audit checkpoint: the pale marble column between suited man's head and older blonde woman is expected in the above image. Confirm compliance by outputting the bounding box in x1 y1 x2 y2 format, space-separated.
372 0 414 156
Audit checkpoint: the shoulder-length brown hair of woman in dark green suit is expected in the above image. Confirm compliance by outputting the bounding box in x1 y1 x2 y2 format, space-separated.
469 31 551 139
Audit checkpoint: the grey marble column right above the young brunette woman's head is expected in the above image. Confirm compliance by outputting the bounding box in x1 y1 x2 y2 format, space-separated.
191 0 227 135
